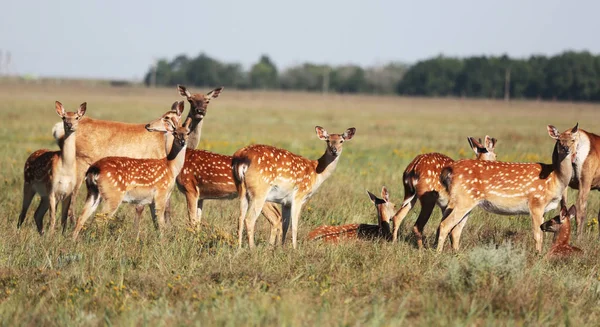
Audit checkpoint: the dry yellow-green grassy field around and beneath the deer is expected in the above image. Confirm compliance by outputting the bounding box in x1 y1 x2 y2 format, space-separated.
0 84 600 326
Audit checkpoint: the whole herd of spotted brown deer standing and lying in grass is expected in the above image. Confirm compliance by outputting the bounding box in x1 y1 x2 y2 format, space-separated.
17 85 600 255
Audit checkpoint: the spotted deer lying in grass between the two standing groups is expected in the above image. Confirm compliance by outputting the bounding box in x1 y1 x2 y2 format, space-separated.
308 186 395 242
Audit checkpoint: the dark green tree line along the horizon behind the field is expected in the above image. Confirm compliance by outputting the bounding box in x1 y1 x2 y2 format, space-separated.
144 51 600 101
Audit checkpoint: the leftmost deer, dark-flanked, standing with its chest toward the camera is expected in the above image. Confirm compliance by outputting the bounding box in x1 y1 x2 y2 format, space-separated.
17 101 87 235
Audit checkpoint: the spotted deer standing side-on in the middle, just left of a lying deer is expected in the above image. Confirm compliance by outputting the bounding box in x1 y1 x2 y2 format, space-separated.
232 126 356 249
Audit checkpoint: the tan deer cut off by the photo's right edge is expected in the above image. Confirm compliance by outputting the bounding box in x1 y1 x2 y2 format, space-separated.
564 125 600 235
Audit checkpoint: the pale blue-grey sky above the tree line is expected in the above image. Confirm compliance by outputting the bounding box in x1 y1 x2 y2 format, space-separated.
0 0 600 79
